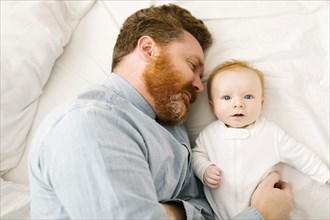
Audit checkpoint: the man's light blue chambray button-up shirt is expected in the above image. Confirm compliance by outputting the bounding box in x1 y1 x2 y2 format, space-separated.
29 74 264 219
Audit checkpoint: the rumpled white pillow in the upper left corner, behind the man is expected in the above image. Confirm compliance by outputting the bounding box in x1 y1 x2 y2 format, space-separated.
0 0 94 176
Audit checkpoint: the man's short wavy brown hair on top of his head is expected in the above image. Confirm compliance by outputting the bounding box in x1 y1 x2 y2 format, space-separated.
112 4 212 70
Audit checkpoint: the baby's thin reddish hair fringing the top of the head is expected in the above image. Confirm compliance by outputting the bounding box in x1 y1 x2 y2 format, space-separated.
207 60 265 101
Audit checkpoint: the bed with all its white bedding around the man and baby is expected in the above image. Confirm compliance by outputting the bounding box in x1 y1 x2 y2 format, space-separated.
0 0 330 219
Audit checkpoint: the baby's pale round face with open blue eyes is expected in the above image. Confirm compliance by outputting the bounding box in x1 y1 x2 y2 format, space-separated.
210 67 263 128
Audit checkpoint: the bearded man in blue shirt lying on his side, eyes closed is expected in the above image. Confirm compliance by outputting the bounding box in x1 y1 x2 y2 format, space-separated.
29 5 292 219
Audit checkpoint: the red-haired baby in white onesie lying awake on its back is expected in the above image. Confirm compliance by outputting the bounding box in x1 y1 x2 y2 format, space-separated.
193 60 330 219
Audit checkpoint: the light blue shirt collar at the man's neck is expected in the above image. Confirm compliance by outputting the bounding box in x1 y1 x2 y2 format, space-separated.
106 73 156 120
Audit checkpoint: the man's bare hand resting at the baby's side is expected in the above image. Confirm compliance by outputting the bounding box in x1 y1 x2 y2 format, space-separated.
251 172 293 219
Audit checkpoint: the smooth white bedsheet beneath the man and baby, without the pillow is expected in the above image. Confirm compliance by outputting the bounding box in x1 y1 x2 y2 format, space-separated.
1 0 330 219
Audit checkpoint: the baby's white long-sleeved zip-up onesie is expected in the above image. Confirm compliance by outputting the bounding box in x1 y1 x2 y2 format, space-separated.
193 117 329 219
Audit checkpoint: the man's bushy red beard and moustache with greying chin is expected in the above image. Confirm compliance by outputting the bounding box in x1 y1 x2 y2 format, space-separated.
143 50 197 125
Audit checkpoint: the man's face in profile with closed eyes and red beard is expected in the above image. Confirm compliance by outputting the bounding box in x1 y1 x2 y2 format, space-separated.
143 31 204 125
